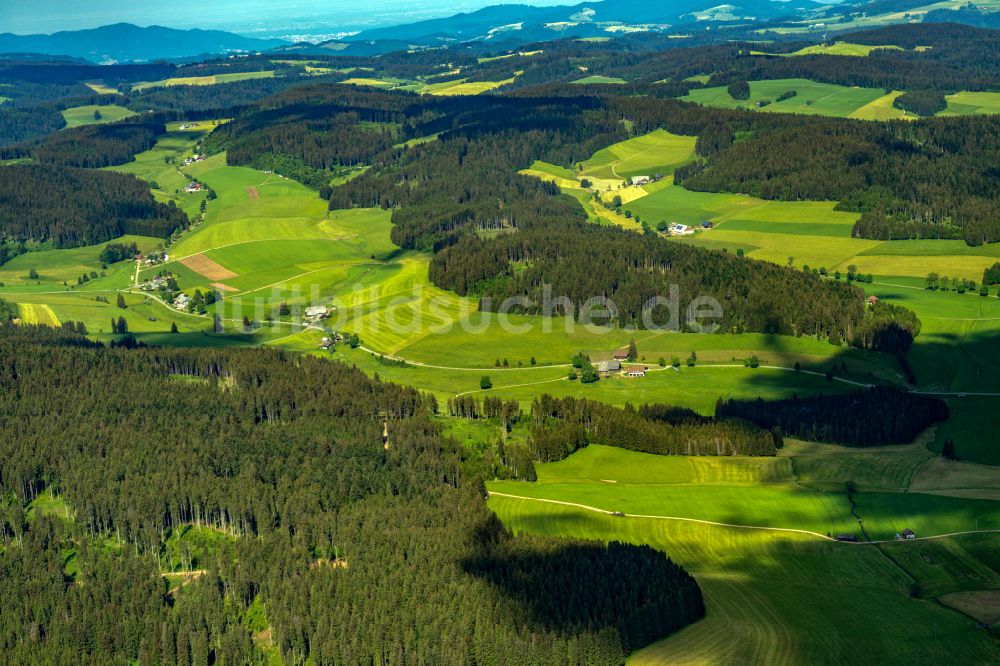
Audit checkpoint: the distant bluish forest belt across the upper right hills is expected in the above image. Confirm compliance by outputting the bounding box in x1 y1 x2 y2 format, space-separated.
474 23 1000 96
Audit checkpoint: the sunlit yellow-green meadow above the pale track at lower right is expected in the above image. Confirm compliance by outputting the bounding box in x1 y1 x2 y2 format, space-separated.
489 443 1000 540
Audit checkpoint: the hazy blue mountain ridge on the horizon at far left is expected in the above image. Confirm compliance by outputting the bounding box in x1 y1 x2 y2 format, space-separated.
0 23 288 63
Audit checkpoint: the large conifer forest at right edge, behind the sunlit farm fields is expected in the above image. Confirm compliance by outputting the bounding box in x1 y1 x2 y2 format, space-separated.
678 116 1000 245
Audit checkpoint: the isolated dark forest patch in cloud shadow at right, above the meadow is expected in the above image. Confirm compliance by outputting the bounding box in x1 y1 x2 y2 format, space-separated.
715 387 948 446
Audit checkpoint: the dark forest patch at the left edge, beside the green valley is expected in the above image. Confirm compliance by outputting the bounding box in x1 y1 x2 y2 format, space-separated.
0 164 189 249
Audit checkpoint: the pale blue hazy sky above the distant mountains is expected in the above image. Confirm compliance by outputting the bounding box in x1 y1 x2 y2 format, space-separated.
0 0 579 38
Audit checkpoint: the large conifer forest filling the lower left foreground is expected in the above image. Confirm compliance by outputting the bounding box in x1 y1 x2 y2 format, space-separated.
0 325 704 665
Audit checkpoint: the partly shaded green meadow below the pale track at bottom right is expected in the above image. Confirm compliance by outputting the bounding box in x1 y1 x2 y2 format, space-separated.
489 496 1000 665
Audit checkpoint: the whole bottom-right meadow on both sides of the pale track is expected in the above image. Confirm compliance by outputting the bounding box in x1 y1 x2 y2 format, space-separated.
489 441 1000 664
